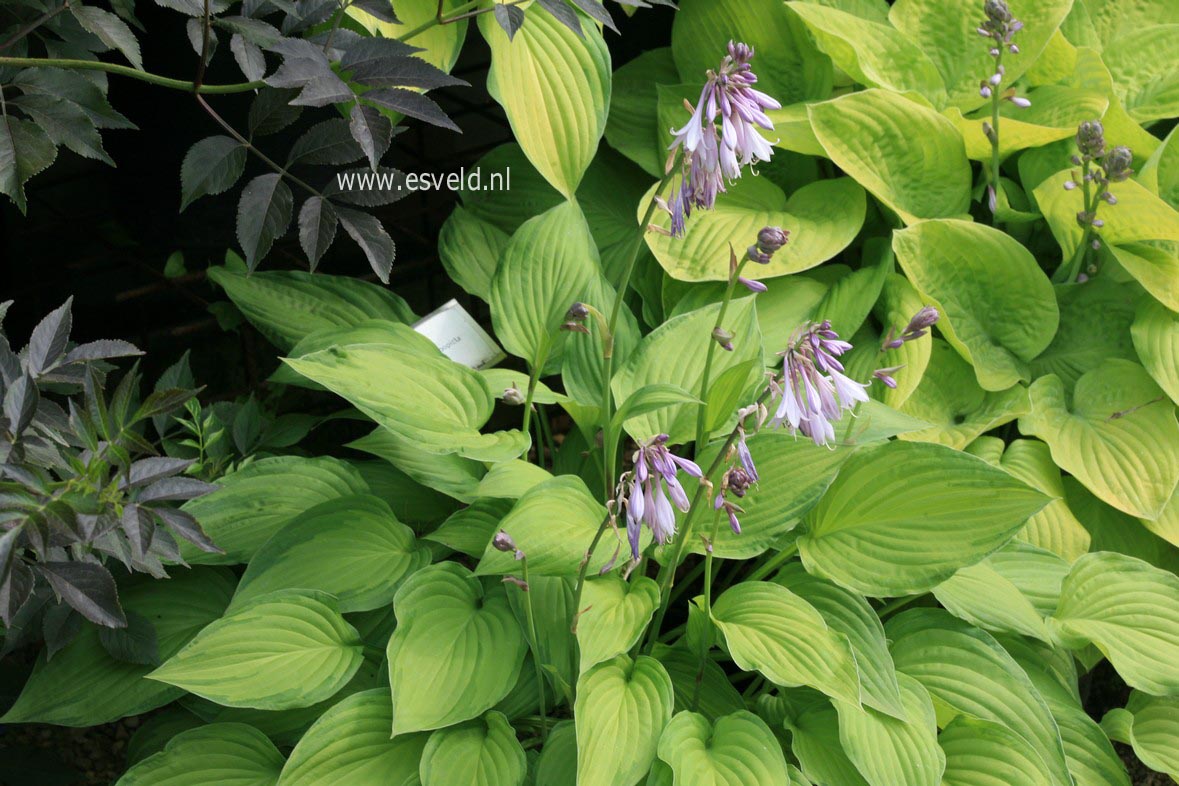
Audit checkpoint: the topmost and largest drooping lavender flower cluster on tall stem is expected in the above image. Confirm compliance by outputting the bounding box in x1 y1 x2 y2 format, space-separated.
667 41 782 237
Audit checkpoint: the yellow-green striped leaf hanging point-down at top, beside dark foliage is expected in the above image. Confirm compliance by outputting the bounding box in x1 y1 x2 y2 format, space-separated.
479 11 611 198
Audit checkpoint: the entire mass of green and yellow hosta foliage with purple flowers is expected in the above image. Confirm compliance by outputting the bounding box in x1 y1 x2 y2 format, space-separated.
4 0 1179 786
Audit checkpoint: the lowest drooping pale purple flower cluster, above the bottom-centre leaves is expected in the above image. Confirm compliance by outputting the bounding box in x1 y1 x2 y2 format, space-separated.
626 434 704 560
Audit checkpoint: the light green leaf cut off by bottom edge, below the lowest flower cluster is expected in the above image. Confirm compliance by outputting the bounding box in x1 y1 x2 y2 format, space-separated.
573 655 672 786
